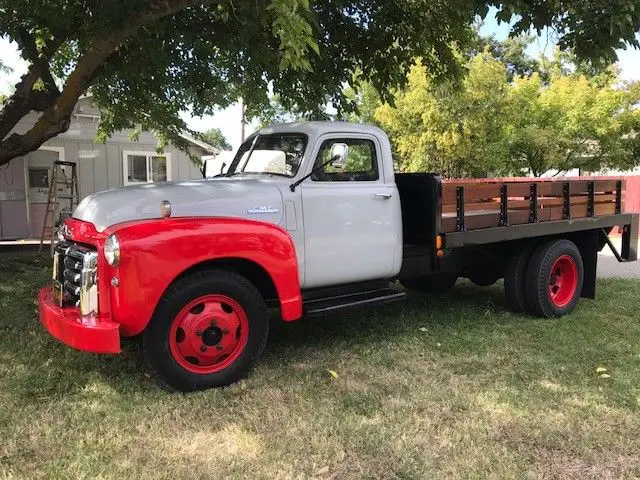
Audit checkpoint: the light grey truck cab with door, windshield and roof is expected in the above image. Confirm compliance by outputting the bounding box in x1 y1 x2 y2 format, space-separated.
230 122 402 288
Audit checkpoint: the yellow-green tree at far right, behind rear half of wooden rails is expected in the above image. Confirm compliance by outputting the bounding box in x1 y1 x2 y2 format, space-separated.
505 71 640 176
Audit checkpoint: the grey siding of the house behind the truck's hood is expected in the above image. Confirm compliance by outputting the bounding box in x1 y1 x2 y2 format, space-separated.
0 99 207 240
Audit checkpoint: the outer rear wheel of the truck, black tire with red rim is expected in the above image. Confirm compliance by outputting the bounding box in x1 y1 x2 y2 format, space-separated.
526 239 584 317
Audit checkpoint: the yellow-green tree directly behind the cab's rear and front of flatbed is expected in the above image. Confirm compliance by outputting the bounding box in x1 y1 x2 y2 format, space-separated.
374 52 508 177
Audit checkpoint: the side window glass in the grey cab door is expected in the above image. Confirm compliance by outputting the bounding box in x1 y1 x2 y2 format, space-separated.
311 138 379 182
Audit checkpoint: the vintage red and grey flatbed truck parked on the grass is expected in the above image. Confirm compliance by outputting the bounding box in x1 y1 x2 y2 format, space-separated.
39 122 638 391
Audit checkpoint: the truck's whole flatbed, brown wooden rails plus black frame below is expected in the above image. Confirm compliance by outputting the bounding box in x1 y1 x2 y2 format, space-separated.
435 177 638 258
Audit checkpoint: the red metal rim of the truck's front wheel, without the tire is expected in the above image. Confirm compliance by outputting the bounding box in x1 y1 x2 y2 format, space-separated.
169 295 249 374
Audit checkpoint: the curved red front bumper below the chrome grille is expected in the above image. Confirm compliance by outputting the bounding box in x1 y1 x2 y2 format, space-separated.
38 287 120 353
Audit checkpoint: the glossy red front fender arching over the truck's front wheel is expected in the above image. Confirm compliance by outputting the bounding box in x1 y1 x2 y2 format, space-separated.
101 217 302 335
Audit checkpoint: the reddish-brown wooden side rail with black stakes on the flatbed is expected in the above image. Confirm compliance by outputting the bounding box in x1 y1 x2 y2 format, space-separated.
441 177 624 233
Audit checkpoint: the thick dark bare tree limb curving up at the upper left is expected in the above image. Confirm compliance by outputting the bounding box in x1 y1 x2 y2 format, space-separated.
0 0 222 165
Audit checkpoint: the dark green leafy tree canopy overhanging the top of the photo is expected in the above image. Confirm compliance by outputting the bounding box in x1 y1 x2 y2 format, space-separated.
0 0 640 165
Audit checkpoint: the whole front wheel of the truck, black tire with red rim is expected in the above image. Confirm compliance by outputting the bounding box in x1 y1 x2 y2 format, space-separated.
142 270 269 392
